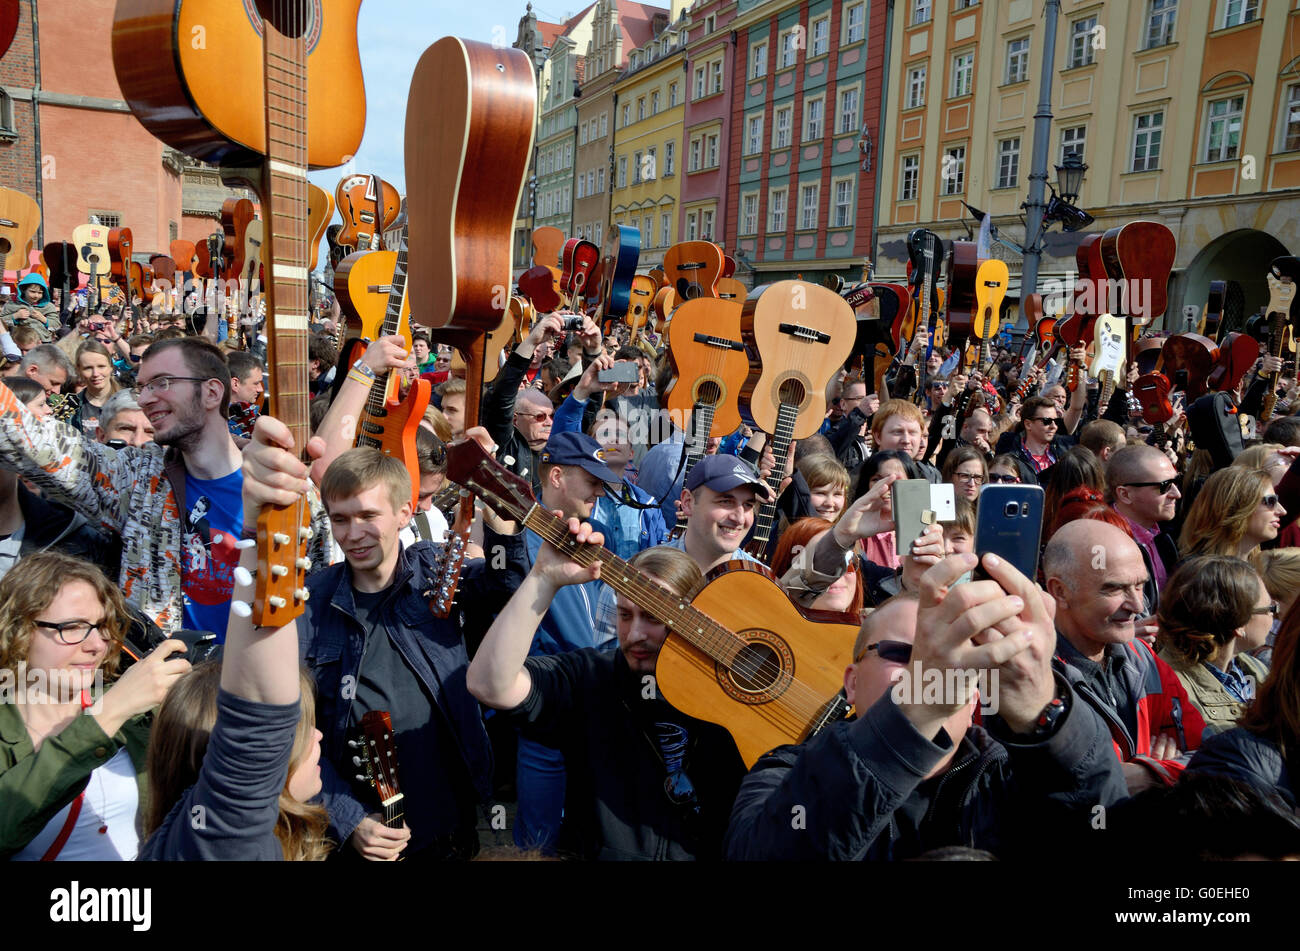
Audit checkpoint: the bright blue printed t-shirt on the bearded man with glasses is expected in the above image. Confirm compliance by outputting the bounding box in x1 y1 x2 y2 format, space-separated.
181 469 243 643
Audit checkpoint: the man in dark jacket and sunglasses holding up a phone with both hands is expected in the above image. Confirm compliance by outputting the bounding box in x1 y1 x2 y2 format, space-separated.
725 555 1126 860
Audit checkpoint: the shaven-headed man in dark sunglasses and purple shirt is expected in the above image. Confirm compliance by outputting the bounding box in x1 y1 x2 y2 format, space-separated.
1088 444 1183 609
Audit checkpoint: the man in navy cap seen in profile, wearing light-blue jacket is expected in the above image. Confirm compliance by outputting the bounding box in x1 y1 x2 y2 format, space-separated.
512 433 621 851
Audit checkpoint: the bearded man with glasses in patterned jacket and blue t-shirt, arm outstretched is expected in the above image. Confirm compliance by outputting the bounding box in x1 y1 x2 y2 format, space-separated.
0 336 329 638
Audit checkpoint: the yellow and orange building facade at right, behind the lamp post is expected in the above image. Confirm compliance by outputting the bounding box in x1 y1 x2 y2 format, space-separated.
876 0 1300 329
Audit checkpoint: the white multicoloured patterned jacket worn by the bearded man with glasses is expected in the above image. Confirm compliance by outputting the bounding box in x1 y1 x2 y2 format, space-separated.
0 383 330 634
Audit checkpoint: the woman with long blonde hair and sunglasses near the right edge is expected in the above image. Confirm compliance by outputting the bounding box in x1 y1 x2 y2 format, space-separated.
1178 465 1286 559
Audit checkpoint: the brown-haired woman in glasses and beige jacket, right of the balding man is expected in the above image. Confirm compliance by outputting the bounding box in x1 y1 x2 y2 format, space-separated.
1156 555 1278 733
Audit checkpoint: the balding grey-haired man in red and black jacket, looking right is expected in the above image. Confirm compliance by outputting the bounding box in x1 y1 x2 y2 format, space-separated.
1043 518 1205 794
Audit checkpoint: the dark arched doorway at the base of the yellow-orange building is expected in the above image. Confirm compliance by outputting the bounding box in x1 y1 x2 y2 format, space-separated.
1165 227 1291 333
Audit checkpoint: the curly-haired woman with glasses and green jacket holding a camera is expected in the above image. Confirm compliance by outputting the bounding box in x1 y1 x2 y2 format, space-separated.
0 552 190 861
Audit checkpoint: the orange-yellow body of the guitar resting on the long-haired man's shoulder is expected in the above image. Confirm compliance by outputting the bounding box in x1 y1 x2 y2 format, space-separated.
655 561 858 767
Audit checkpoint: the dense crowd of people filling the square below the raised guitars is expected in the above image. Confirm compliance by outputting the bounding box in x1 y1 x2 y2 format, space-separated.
0 265 1300 860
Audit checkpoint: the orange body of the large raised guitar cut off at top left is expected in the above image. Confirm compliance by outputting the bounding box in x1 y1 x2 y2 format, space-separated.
113 0 365 169
